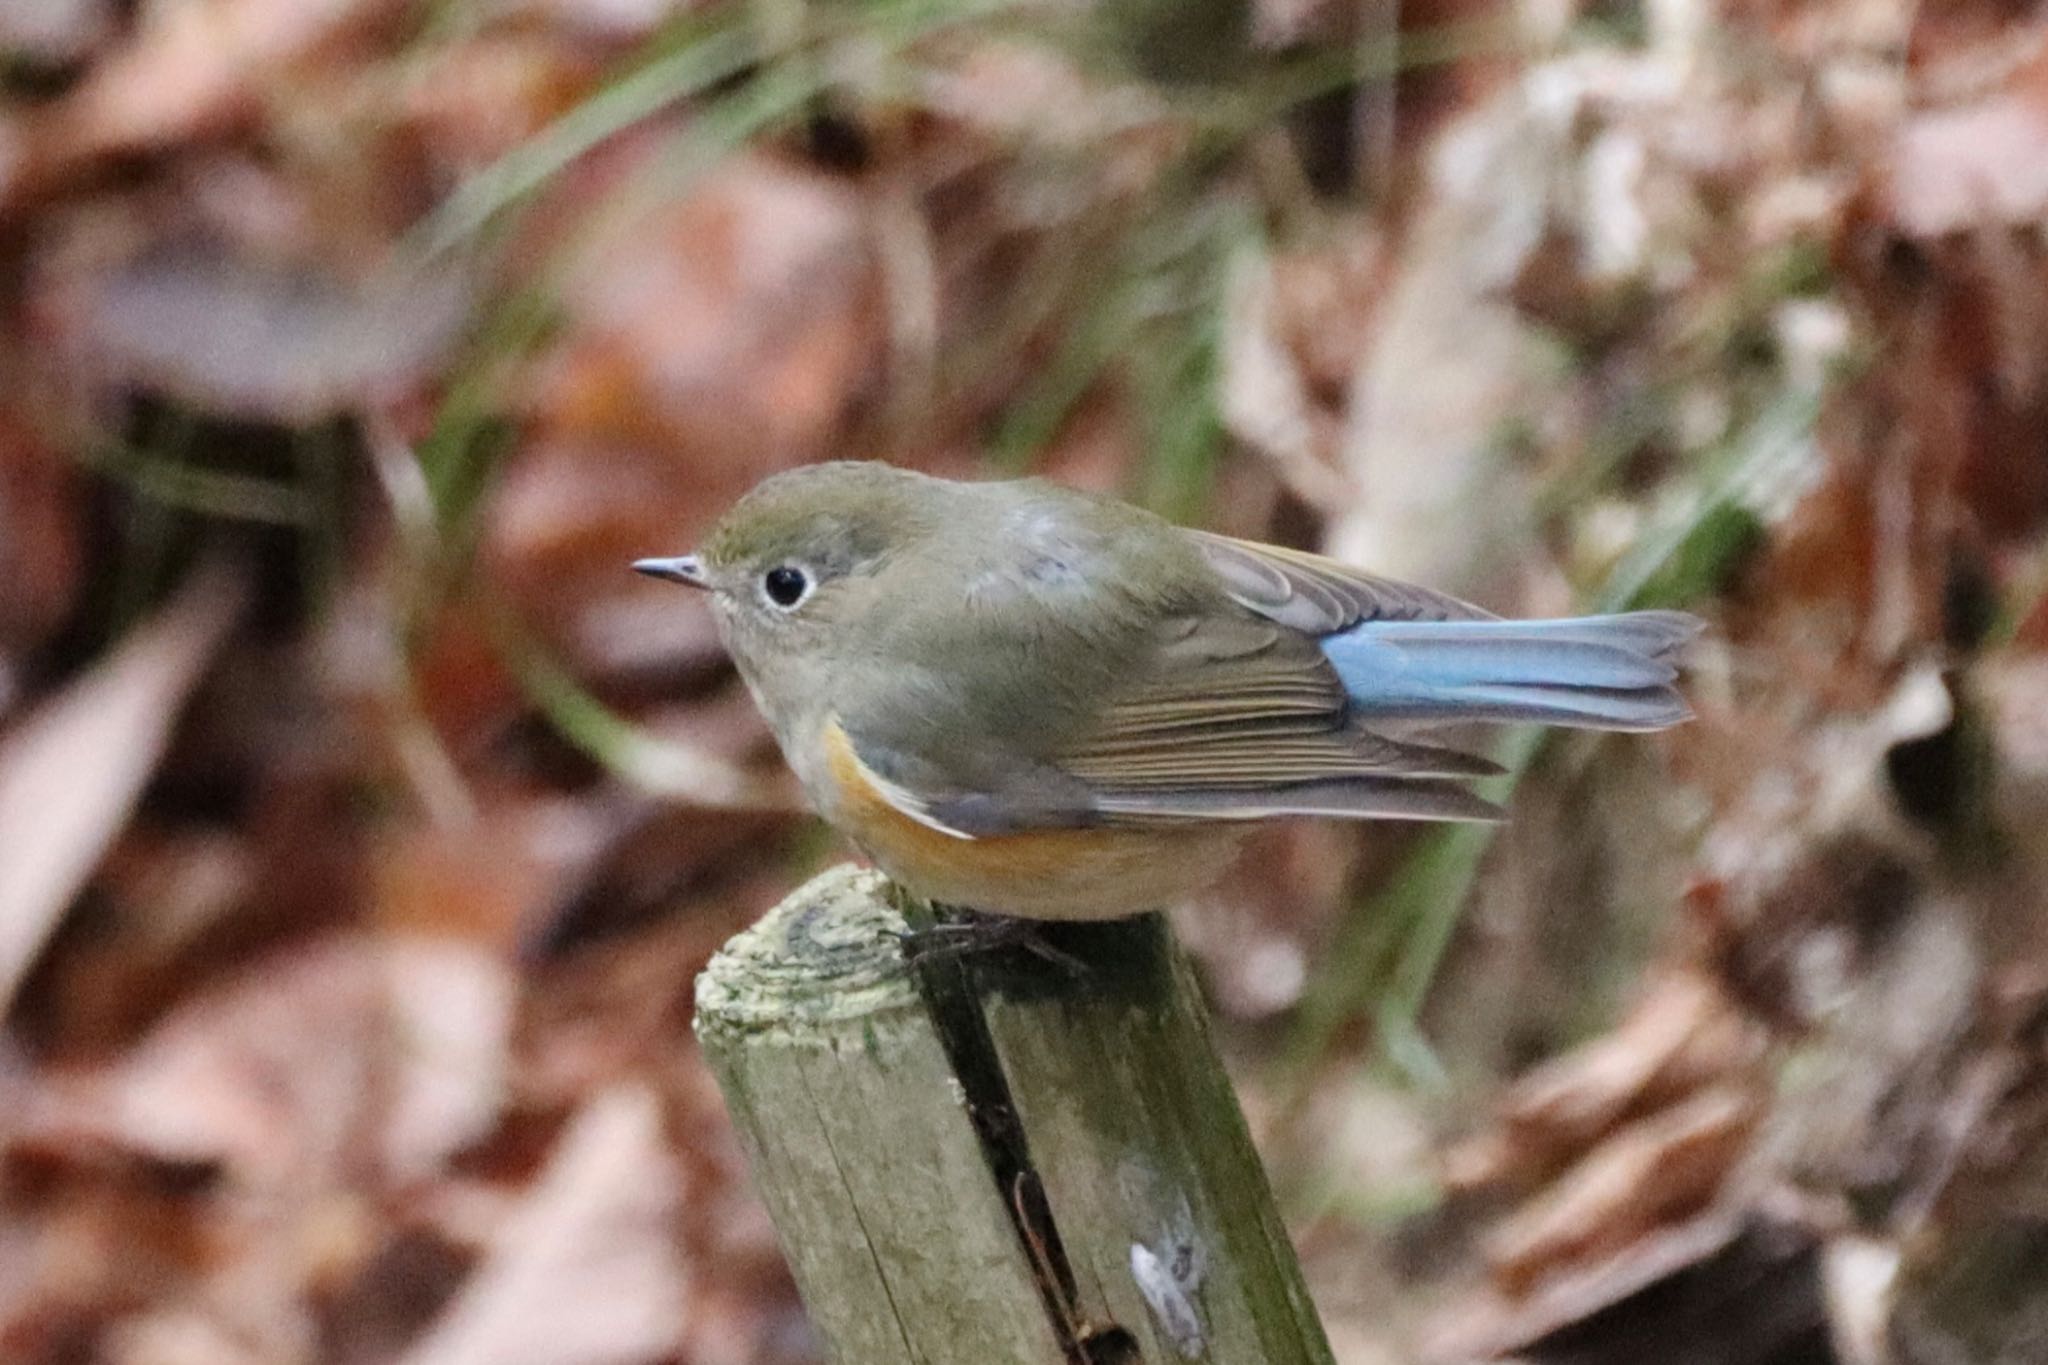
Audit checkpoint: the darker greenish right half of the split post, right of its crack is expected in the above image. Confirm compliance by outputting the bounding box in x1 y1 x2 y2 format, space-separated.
973 915 1331 1363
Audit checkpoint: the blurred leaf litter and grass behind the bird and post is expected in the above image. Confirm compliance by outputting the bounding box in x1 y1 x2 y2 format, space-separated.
0 0 2048 1365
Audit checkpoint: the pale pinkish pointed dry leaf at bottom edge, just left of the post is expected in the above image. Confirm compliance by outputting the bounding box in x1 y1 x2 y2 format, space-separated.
403 1085 688 1365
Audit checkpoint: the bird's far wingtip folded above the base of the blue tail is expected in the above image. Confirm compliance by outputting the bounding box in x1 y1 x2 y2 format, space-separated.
1186 530 1493 636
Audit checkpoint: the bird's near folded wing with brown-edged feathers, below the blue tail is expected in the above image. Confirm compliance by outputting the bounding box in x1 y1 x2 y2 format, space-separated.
835 614 1499 837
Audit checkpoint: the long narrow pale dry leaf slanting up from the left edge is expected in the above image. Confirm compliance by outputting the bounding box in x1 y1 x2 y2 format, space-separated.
0 571 246 1011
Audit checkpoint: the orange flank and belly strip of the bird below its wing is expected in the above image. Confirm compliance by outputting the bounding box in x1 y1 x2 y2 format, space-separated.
821 718 1241 919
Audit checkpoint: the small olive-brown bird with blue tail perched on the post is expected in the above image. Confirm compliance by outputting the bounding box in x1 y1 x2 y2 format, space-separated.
633 463 1700 919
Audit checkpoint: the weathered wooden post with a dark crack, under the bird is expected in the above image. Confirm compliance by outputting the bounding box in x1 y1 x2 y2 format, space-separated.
696 868 1331 1365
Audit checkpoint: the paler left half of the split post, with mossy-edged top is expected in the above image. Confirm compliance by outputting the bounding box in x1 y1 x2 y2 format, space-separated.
696 868 1067 1365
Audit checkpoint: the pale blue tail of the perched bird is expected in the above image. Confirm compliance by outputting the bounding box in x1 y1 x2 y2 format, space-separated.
1323 612 1700 731
